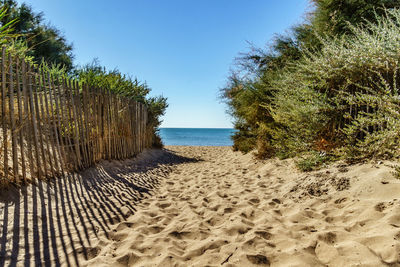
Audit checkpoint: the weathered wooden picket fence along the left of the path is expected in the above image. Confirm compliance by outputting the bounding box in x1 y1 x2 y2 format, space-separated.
0 48 150 186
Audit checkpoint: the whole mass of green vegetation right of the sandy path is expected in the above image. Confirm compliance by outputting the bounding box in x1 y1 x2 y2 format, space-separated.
222 0 400 170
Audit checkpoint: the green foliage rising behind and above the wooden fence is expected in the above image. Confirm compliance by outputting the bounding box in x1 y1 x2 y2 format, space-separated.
0 0 168 147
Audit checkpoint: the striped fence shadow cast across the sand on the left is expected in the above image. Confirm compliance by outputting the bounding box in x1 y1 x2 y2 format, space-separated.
0 149 199 266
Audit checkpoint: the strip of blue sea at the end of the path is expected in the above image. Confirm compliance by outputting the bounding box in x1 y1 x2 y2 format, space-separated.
160 128 236 146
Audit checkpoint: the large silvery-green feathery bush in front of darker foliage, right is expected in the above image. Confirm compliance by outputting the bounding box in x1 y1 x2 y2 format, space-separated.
264 10 400 160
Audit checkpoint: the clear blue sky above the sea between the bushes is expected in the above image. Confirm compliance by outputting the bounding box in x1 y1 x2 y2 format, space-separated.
18 0 309 128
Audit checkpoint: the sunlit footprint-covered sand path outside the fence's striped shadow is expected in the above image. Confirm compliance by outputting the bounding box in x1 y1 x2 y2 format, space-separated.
88 147 400 266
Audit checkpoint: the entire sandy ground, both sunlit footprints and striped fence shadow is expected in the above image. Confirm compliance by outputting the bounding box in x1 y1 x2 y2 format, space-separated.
0 147 400 267
